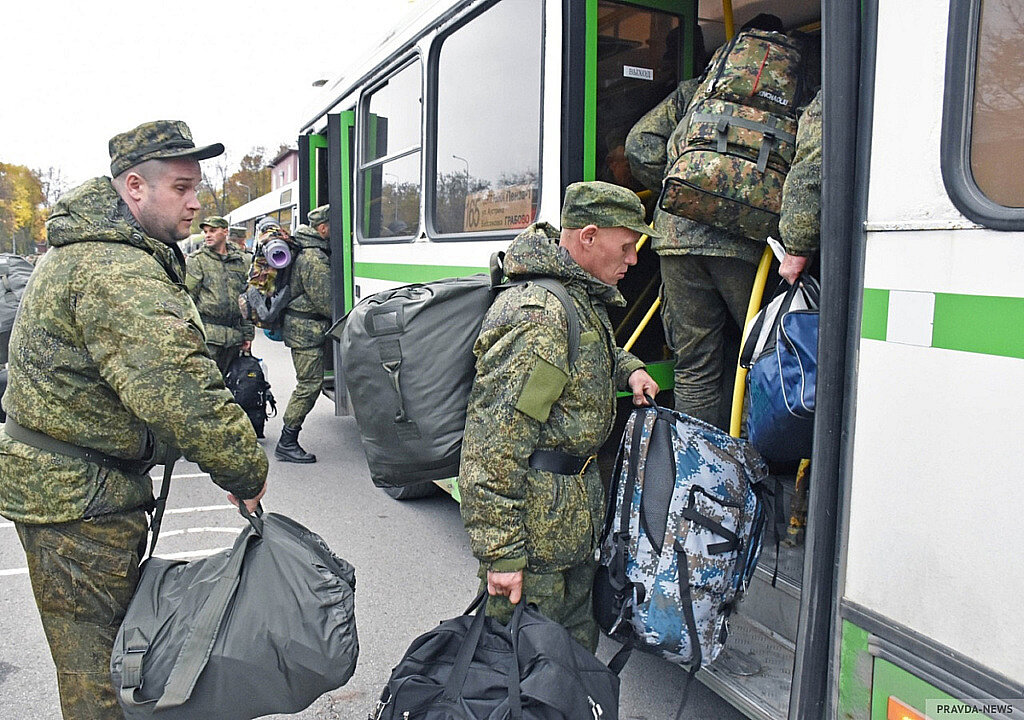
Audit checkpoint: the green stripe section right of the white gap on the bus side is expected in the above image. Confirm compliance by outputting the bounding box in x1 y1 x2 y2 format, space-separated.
932 293 1024 357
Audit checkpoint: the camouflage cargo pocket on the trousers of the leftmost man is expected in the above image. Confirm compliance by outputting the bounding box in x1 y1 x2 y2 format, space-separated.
39 513 145 627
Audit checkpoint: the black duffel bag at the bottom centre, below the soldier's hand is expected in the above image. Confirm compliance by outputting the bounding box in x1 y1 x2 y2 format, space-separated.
371 591 618 720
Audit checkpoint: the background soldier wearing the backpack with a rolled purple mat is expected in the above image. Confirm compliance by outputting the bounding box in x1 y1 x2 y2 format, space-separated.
273 205 331 463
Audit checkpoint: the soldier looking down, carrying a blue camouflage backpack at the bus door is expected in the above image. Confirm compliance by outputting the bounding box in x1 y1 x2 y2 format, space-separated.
459 182 657 650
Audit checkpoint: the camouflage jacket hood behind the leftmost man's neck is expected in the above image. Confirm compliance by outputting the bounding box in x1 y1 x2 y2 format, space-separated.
46 177 184 283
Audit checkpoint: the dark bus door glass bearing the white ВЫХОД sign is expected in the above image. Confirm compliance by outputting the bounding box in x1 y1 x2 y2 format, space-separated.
595 0 682 190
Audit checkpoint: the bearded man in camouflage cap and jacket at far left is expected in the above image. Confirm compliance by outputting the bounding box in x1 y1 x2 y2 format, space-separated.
0 121 267 720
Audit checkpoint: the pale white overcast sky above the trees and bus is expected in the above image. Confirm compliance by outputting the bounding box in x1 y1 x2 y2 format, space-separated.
0 0 429 186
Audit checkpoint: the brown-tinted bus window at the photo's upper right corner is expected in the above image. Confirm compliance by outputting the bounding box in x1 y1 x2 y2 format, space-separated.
971 0 1024 208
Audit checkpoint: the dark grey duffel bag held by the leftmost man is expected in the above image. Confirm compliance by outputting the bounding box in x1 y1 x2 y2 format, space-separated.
111 487 358 720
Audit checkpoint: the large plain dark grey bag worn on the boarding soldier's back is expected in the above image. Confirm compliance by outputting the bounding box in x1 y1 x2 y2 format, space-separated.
329 253 580 488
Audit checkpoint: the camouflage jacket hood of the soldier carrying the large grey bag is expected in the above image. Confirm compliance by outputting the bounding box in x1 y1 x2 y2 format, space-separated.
505 222 626 307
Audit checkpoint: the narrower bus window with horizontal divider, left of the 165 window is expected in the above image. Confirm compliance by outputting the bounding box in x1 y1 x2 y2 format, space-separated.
359 60 423 240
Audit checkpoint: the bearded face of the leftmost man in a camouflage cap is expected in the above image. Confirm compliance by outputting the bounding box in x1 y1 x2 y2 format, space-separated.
137 158 203 243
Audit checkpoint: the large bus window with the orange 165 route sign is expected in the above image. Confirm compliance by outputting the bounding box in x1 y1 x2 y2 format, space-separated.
431 0 544 235
